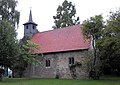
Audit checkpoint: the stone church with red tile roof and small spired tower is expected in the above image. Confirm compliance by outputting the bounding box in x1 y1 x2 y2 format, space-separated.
24 11 91 79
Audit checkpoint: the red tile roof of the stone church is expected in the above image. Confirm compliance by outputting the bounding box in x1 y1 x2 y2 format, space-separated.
32 25 90 53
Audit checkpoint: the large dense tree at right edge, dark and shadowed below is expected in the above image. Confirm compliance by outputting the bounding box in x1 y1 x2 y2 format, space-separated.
97 10 120 75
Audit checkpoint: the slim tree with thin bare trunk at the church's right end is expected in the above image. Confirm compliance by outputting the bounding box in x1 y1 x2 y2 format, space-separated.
82 15 104 79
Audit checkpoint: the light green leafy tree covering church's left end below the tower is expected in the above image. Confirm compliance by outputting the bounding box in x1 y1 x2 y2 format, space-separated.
13 40 40 77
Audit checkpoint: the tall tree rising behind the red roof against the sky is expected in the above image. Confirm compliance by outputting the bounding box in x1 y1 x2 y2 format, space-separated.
53 0 80 29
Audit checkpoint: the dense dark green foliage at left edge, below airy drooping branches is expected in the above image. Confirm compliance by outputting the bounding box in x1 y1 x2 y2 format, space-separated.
0 20 18 67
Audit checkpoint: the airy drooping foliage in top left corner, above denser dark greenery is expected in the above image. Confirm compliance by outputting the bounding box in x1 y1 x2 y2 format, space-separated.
0 0 20 26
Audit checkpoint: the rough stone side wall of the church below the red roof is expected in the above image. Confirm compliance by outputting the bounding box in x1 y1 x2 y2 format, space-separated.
24 51 88 79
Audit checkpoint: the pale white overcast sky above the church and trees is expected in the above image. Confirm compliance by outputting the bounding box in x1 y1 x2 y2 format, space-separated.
17 0 120 39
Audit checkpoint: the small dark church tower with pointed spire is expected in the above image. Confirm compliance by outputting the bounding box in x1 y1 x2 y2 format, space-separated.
23 10 38 39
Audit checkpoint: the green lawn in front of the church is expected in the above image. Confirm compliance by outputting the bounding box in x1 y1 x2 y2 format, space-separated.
0 77 120 85
